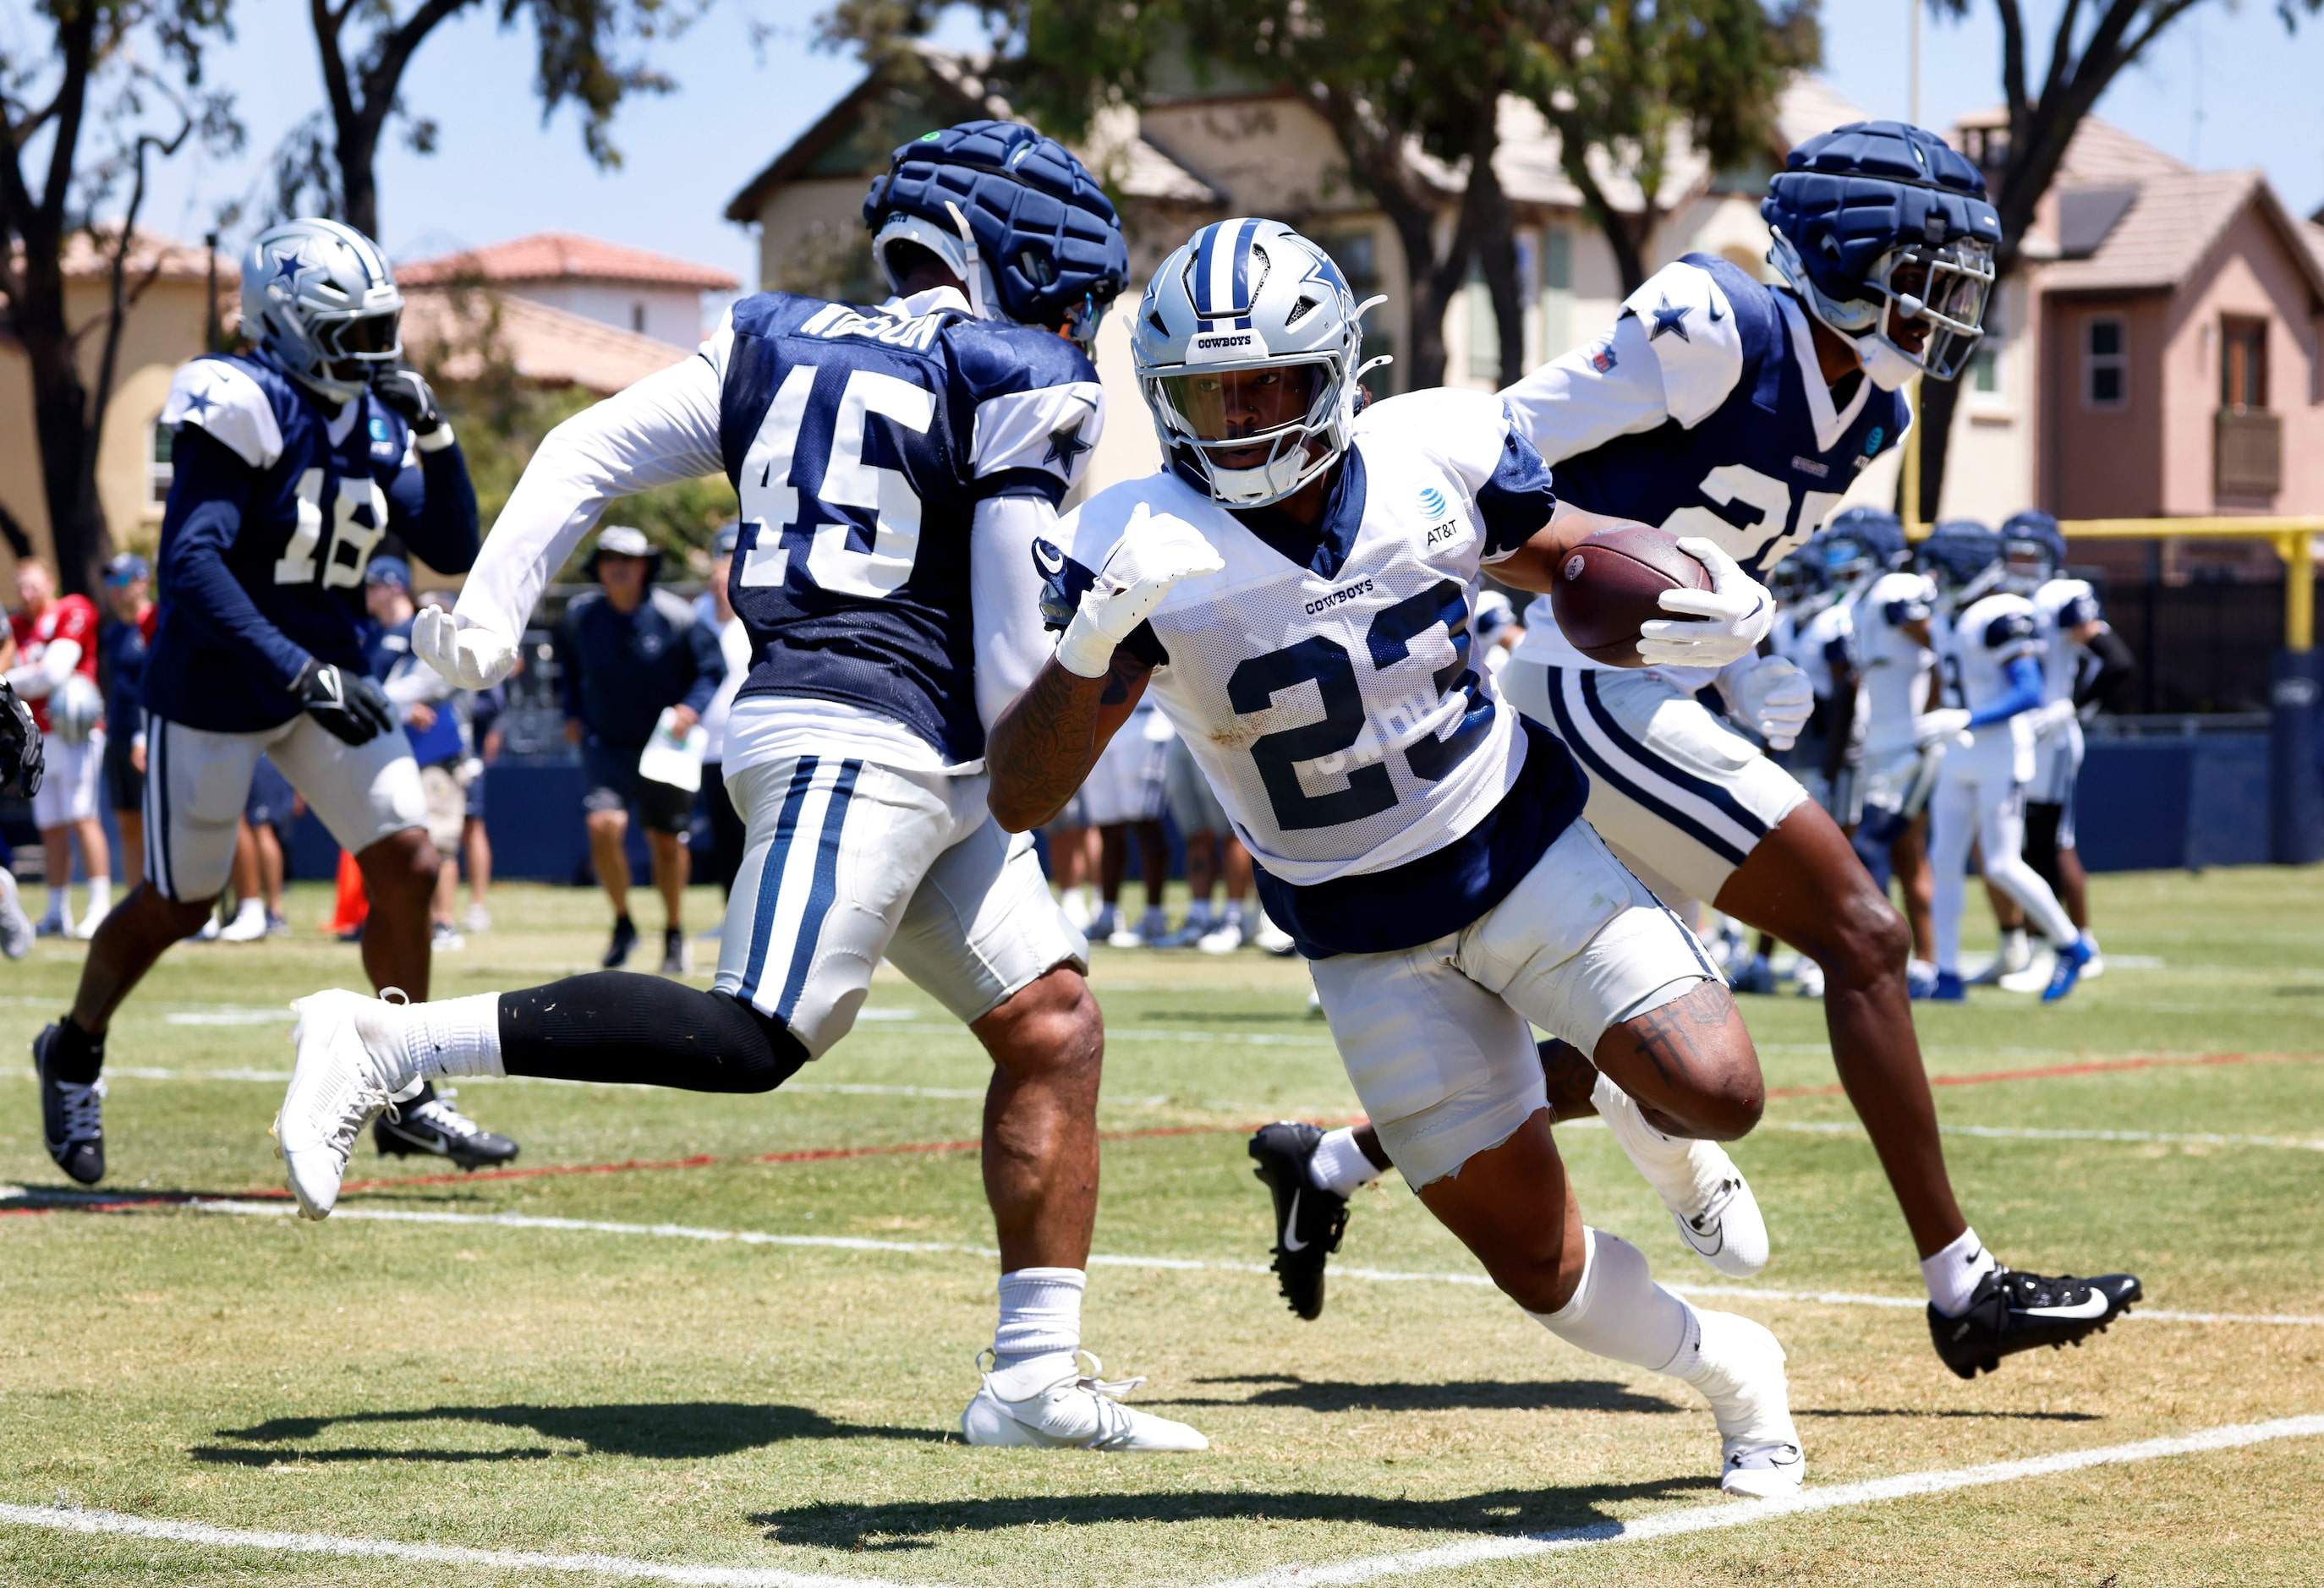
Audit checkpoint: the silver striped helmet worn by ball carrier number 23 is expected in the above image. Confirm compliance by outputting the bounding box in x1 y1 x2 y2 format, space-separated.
1130 216 1388 507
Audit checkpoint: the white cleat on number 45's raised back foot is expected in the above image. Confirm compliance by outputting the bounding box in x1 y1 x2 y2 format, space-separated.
272 988 423 1218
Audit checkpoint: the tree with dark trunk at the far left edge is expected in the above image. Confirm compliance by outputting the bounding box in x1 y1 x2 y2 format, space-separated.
0 0 242 593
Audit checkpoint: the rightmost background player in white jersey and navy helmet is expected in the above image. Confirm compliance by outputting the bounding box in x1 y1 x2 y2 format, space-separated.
2001 509 2135 981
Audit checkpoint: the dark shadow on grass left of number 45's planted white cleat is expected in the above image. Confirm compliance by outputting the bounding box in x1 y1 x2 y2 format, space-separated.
189 1399 945 1467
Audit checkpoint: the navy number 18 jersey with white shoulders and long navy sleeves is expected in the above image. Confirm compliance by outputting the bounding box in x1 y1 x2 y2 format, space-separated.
144 353 476 732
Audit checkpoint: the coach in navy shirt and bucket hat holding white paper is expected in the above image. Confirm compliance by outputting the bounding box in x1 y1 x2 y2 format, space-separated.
558 525 725 977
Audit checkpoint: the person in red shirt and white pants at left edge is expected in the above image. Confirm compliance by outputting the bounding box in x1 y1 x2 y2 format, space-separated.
7 558 114 937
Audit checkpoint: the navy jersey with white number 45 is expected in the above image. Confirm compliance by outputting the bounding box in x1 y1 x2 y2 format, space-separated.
704 291 1104 765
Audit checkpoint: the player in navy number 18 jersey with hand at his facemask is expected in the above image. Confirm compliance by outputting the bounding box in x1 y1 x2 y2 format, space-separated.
32 221 518 1186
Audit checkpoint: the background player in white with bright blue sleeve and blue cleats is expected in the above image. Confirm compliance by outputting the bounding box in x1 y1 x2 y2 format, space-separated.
1915 534 2094 1002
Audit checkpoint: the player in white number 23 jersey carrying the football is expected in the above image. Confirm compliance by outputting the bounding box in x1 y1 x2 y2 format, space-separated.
988 218 1803 1495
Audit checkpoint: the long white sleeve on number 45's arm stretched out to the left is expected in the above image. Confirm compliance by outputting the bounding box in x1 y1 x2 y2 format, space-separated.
456 319 715 635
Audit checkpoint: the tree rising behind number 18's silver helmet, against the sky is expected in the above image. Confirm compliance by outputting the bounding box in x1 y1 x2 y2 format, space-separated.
277 0 709 237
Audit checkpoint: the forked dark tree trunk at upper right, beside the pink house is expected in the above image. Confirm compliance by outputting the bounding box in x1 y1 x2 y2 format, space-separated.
1920 0 2324 518
